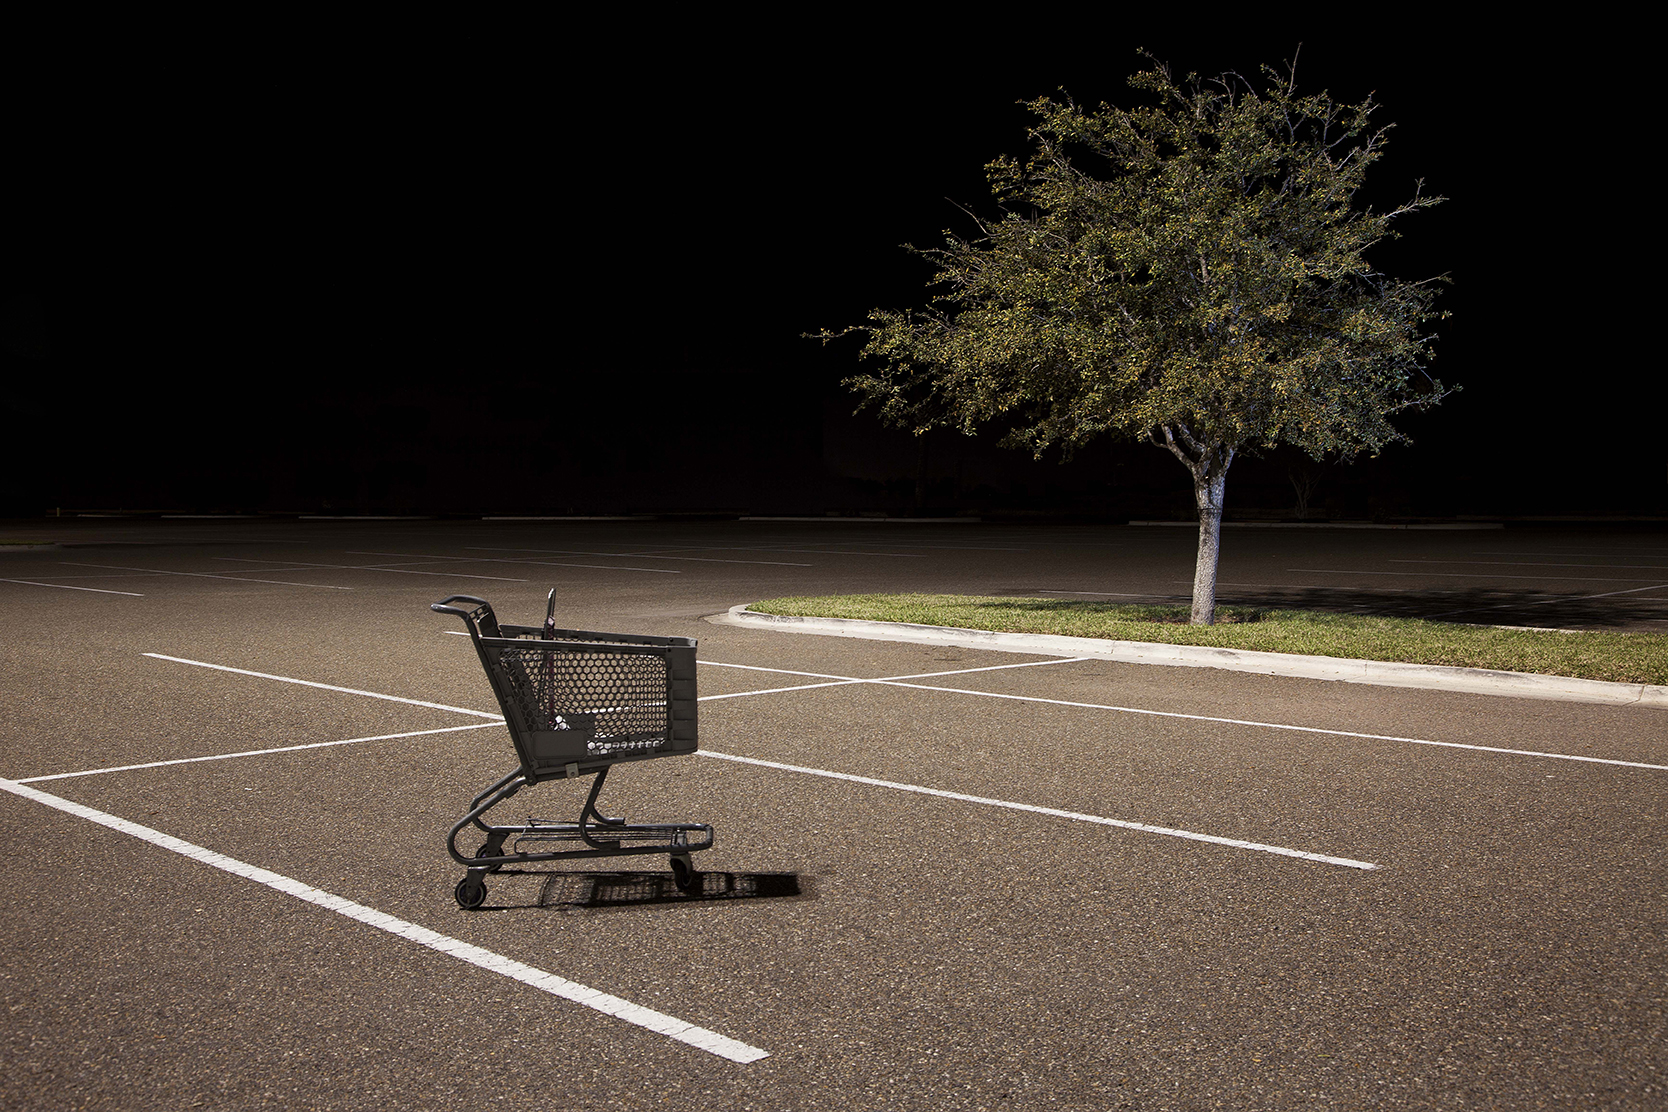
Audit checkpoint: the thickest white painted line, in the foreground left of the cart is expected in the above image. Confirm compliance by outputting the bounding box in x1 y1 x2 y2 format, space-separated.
0 780 769 1065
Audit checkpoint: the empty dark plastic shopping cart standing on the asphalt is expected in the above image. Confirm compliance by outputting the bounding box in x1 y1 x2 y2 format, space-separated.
429 590 712 910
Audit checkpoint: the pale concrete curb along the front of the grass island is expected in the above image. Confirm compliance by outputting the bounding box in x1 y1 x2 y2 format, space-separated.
707 604 1668 710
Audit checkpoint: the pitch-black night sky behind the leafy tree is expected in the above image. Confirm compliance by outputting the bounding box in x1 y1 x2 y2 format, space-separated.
0 17 1668 513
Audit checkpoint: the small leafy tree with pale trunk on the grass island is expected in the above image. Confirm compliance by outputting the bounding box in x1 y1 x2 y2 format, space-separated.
817 57 1446 625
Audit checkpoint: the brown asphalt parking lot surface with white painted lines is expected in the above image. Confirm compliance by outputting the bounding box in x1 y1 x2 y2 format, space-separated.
0 523 1668 1109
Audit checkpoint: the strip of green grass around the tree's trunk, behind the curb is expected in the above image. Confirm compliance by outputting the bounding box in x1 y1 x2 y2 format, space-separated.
747 595 1668 684
